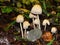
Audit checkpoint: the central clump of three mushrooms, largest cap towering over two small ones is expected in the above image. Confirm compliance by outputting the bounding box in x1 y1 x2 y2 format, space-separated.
30 4 42 29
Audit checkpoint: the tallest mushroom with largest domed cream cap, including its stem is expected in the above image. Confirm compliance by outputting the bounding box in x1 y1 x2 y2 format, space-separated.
31 4 42 29
